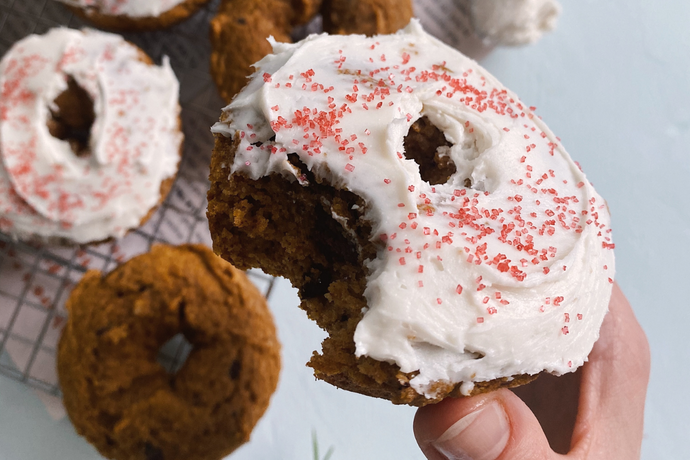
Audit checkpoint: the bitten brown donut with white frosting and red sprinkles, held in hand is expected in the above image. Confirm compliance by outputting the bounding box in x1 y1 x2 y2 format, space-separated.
208 21 614 405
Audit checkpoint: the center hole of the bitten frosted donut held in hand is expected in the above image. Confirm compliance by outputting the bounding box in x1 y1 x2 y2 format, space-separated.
404 117 456 187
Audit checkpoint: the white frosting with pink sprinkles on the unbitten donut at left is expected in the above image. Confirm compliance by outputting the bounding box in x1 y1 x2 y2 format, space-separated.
0 28 182 243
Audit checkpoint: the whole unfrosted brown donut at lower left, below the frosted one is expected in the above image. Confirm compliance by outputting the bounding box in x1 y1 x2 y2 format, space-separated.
58 245 280 460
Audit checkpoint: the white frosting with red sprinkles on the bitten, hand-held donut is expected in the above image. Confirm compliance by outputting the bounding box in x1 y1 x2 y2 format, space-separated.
213 21 614 397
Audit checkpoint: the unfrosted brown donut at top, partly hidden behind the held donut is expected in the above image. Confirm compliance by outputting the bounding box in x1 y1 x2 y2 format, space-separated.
211 0 412 102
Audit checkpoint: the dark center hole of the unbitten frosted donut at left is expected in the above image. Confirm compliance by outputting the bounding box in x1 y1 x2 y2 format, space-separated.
47 76 96 157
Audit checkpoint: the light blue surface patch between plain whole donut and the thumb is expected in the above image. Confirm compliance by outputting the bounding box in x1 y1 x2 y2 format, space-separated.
220 280 416 460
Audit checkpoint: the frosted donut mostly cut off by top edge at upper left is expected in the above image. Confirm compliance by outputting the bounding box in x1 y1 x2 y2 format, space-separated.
58 0 209 32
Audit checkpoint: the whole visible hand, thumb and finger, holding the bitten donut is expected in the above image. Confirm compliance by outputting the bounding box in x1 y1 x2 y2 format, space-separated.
414 284 650 460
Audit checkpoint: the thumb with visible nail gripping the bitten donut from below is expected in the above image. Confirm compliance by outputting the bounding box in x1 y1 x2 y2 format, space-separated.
414 389 560 460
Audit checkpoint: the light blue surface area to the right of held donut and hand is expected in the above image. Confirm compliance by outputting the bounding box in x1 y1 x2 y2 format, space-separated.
482 0 690 460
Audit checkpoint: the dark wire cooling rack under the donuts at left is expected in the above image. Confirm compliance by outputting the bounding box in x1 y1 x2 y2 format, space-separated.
0 0 274 396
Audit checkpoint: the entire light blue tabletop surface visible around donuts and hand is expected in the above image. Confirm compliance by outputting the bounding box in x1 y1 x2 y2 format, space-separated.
0 0 690 460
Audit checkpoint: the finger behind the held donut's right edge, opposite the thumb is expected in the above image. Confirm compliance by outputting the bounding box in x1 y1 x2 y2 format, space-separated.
571 285 650 459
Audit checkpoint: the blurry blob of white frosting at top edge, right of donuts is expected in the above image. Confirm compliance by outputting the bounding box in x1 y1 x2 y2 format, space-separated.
471 0 561 46
